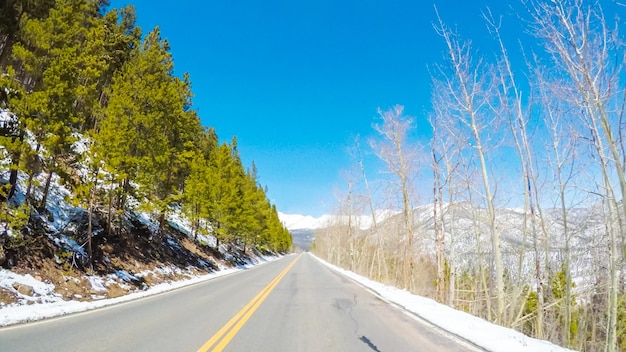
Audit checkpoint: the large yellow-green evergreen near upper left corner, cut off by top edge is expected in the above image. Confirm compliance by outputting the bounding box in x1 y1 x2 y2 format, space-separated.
13 0 106 208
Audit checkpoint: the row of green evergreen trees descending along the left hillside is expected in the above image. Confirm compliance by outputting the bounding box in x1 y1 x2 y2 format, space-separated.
0 0 291 251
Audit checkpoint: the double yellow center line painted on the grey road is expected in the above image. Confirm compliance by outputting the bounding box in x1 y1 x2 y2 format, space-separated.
198 255 300 352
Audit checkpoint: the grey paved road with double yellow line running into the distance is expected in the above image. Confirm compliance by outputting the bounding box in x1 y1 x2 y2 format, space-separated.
0 254 478 352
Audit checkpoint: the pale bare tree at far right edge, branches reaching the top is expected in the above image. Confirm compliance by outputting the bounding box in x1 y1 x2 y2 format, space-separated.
532 0 626 351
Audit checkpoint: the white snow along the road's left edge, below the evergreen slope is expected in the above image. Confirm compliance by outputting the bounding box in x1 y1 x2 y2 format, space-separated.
0 256 279 327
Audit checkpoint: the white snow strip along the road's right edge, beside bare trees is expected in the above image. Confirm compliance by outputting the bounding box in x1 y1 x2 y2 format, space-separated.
313 255 572 352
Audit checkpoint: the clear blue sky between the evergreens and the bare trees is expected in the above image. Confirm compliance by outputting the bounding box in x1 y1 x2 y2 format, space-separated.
111 0 519 216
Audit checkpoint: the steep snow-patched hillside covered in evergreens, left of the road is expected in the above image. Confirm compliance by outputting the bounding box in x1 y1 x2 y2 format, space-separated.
0 0 291 292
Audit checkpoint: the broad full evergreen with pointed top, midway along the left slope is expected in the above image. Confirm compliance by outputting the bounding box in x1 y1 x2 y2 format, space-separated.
97 28 202 235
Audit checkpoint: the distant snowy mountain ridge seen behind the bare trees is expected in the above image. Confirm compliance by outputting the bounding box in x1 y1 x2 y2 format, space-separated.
278 202 608 276
